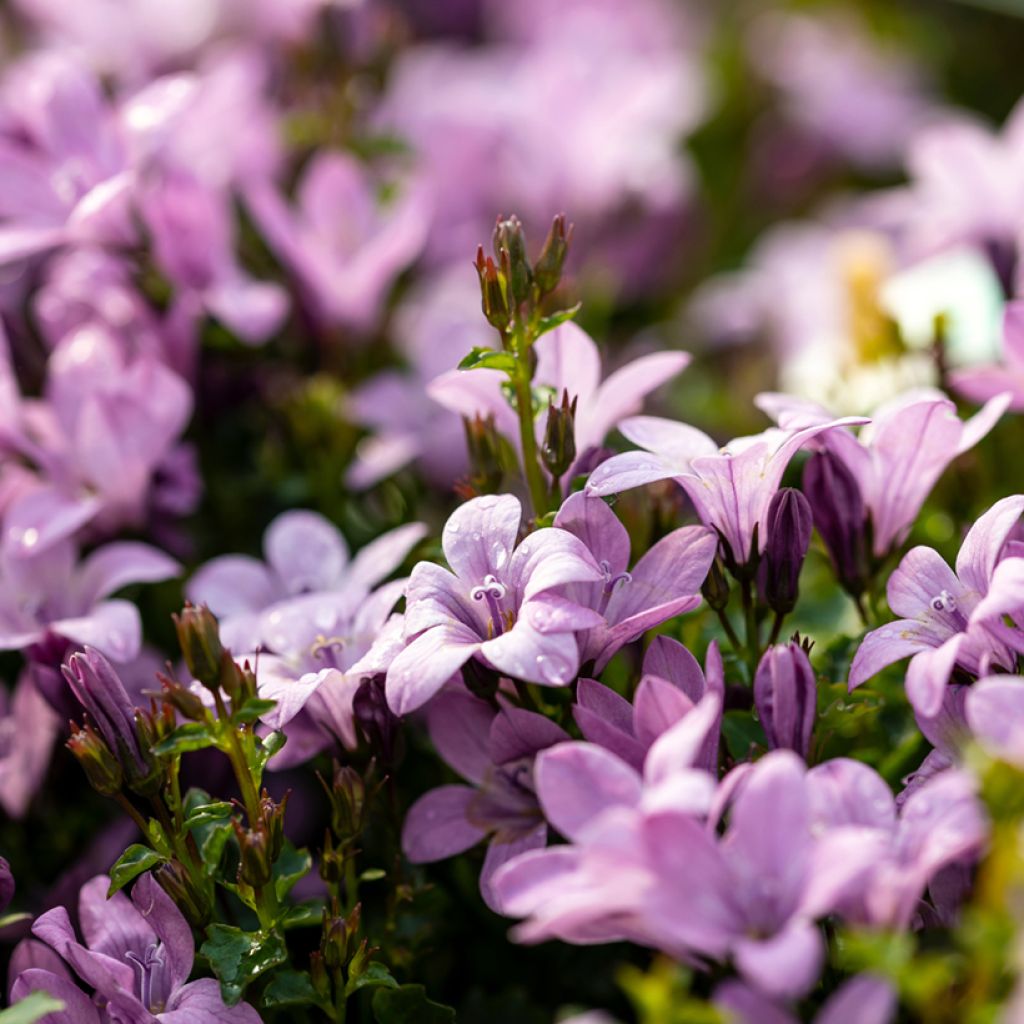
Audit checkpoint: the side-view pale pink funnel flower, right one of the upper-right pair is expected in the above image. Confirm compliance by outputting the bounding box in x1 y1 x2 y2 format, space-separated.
757 388 1010 558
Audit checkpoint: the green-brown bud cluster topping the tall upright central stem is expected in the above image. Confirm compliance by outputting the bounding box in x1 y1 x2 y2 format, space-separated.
474 214 572 335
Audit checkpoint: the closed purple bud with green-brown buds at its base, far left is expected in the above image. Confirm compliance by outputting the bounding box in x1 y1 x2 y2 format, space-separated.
63 647 163 796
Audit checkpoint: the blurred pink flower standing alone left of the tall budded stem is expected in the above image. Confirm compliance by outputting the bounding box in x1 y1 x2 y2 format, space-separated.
247 152 430 330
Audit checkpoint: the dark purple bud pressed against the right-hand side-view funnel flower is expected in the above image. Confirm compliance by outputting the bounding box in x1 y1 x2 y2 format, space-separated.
804 452 869 597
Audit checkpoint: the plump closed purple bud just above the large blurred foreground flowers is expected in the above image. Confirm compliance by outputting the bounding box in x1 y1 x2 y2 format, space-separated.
754 643 818 758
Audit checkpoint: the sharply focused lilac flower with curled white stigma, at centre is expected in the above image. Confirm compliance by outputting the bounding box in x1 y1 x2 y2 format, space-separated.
387 495 604 715
